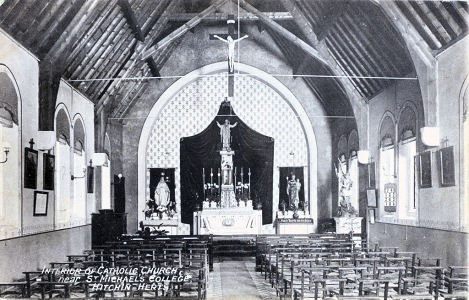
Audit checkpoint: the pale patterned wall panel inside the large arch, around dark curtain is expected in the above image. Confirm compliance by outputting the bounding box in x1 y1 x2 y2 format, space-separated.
146 74 308 233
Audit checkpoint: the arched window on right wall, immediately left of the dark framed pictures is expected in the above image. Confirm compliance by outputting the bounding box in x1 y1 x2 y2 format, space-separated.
397 105 418 219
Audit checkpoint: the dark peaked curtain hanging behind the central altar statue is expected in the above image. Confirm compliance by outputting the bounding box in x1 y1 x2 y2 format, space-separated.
180 102 274 226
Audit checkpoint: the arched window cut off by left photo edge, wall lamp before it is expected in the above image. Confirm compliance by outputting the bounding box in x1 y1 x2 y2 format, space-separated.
0 65 22 239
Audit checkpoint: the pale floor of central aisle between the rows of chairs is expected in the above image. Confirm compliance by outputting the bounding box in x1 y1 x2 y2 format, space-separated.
207 257 278 300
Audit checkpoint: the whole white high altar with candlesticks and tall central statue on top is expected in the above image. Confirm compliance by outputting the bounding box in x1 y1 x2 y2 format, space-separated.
193 120 262 235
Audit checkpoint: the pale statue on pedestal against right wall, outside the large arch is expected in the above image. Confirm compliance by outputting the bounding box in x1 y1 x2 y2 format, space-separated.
335 154 357 217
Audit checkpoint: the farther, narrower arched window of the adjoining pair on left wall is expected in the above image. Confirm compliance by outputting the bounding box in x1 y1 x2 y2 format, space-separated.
72 118 87 226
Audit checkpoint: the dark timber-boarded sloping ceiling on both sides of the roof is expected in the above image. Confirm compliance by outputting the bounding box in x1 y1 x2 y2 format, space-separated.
0 0 469 117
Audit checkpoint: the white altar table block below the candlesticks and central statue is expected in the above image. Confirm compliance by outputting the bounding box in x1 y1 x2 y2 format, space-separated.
193 205 262 235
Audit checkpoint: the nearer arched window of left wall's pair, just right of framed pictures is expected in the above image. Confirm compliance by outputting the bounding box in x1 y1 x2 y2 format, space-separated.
54 105 73 229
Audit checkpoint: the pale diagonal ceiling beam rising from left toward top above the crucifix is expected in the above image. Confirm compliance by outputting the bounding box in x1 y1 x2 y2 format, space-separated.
141 0 228 59
